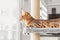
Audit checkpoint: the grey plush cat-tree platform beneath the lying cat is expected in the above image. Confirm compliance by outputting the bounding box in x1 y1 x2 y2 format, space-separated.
24 28 60 37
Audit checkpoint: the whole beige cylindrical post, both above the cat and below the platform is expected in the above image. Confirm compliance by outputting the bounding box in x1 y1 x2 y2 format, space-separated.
31 0 40 40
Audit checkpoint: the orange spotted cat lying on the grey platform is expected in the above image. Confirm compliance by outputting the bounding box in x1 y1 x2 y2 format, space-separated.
20 11 60 28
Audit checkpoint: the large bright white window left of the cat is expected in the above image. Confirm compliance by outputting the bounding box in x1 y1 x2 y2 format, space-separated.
0 0 19 40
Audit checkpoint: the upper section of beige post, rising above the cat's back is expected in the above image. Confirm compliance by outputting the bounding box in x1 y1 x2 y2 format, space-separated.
31 0 40 19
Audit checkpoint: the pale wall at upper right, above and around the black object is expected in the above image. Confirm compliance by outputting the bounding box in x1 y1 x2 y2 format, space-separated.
48 0 60 14
